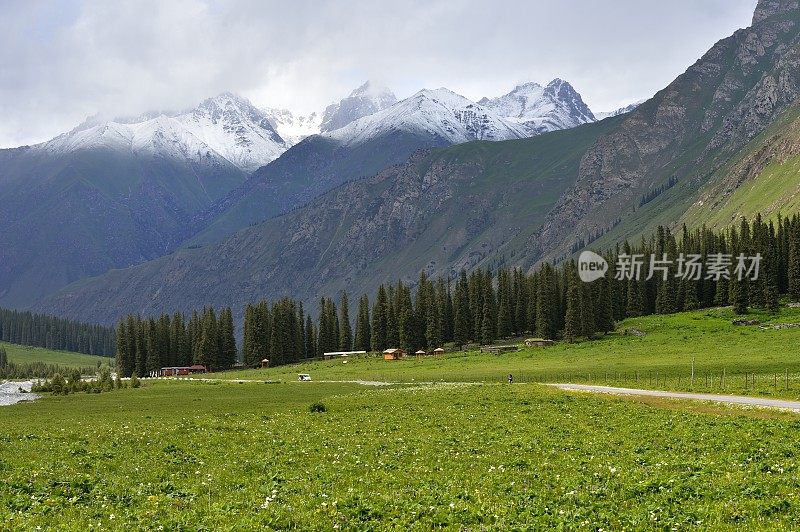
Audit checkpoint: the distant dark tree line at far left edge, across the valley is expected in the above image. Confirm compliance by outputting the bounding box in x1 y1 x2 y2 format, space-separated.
0 308 116 357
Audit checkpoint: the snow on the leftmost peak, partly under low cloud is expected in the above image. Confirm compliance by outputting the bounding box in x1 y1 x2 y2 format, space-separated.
38 93 289 173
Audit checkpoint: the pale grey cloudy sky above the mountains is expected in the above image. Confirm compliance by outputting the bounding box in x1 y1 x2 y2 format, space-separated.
0 0 756 147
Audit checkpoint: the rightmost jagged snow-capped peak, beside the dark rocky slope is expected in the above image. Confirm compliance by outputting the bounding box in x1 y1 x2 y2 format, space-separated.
478 79 595 136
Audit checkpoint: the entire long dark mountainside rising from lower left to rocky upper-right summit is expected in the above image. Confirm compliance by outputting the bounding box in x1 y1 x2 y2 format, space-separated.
38 0 800 323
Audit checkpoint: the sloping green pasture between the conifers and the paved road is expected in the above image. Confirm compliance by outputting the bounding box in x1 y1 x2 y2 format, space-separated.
216 308 800 398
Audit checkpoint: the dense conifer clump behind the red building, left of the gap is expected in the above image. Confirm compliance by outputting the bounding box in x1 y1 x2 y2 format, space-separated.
116 307 237 377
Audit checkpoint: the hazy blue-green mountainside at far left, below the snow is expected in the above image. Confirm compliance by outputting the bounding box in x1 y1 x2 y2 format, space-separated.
0 147 244 307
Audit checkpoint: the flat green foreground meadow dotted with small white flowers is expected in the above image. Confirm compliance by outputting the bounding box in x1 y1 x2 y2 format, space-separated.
0 381 800 530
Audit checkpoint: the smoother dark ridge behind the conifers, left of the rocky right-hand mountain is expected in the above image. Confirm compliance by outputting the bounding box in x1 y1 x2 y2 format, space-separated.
42 119 620 323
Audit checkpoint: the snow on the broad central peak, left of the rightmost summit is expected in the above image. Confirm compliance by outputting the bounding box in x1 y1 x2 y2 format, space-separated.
323 88 529 146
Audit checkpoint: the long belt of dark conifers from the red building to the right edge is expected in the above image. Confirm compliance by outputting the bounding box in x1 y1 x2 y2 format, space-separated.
117 215 800 374
